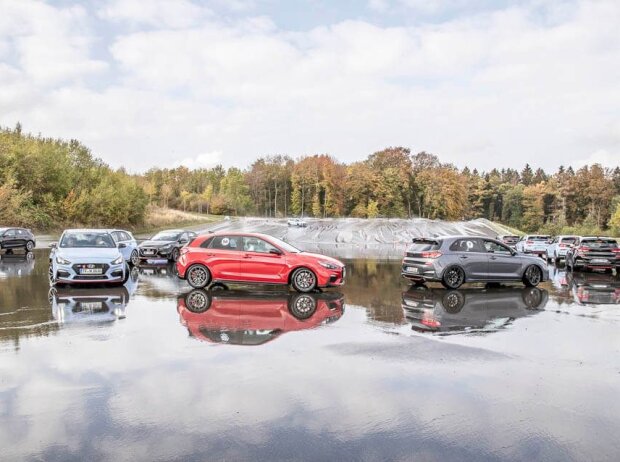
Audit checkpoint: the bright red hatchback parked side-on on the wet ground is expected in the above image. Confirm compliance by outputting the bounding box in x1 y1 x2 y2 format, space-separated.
177 233 346 292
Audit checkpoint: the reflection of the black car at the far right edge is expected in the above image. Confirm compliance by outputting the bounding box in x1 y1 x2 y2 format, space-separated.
566 272 620 305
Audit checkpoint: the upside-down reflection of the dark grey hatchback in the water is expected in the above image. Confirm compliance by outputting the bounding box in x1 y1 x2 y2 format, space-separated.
402 286 549 334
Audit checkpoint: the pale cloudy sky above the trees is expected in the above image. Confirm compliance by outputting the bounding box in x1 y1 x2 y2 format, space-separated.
0 0 620 171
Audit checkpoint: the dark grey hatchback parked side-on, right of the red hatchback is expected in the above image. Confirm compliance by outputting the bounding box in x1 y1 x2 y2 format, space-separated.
401 236 549 289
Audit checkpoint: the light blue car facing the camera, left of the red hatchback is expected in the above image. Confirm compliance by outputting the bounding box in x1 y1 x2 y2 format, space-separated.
49 229 129 286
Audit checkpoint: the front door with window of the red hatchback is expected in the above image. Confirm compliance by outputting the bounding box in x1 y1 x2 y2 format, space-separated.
240 236 287 284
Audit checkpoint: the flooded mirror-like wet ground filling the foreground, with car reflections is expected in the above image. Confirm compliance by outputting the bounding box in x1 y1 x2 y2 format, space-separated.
0 251 620 461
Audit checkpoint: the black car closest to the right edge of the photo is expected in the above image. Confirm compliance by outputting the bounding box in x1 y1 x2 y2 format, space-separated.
566 237 620 271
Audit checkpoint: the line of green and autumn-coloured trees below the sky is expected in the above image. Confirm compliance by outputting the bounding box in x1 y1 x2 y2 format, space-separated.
0 126 620 234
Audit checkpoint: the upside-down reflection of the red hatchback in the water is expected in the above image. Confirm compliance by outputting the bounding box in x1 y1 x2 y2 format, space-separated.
177 289 344 345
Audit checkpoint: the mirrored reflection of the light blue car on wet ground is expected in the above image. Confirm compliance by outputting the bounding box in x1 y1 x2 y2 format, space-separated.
48 268 138 324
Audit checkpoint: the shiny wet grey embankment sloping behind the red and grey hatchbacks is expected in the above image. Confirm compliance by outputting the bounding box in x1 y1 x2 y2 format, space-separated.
199 218 509 258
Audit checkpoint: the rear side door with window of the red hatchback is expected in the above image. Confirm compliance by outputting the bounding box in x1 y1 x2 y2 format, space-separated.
201 235 243 281
